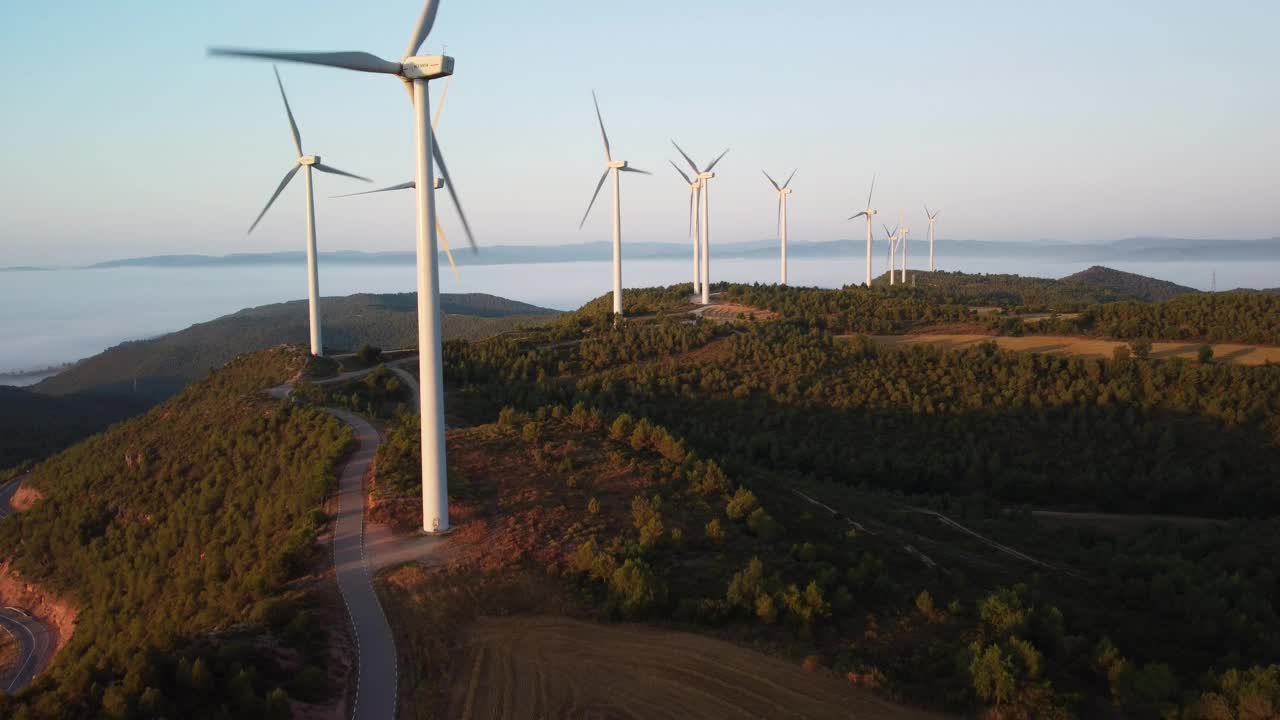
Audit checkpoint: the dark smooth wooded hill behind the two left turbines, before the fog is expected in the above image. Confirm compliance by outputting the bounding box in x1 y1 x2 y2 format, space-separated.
33 293 556 400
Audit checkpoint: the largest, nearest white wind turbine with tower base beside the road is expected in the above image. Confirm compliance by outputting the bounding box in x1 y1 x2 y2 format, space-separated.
210 0 475 532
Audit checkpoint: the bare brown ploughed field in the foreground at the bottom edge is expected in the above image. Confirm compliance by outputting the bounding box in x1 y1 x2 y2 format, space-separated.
447 616 941 720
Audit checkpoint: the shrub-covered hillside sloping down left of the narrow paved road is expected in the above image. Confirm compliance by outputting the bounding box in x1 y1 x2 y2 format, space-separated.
0 347 351 719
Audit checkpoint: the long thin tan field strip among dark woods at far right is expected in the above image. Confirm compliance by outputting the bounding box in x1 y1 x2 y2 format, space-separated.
870 333 1280 365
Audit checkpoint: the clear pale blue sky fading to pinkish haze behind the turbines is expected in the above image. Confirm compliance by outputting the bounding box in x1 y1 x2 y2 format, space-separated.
0 0 1280 266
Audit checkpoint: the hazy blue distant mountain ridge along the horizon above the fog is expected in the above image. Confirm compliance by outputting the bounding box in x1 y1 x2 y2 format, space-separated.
3 237 1280 272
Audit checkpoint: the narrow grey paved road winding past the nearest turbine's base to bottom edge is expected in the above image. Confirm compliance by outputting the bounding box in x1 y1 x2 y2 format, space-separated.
326 409 399 720
